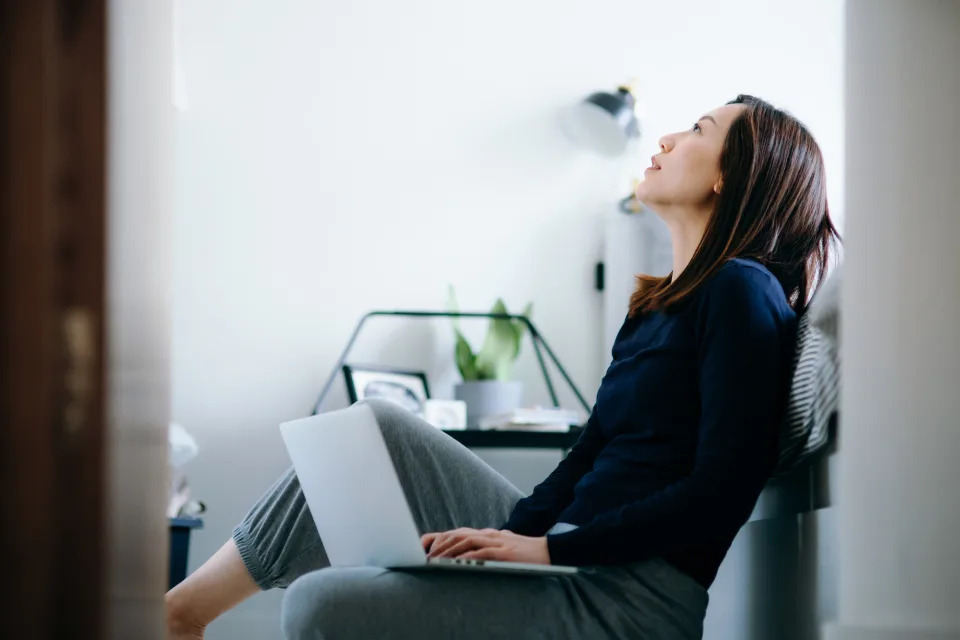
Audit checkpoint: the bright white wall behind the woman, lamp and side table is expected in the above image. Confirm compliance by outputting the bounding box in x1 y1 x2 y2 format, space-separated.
173 0 843 638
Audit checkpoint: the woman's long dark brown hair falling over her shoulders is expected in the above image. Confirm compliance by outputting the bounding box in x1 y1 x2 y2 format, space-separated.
629 95 841 317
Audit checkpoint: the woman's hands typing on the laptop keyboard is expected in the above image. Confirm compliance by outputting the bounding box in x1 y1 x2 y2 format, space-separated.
420 528 550 564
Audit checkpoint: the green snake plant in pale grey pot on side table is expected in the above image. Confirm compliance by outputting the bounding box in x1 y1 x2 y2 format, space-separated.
448 286 533 429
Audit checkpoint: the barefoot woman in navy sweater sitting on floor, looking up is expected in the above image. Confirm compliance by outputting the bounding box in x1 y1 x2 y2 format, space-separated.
167 96 839 639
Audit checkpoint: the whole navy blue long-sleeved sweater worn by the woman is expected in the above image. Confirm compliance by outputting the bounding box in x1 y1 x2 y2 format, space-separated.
503 258 796 587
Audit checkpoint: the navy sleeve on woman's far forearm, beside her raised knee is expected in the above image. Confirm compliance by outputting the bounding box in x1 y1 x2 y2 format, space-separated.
501 406 604 536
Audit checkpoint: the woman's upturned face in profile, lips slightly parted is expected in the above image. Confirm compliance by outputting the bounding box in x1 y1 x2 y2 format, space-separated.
636 104 746 213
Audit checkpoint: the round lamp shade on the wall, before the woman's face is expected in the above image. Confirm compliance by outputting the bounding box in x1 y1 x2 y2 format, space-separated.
565 87 640 156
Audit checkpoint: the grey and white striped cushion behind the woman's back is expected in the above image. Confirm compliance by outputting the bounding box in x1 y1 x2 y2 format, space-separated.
773 267 840 477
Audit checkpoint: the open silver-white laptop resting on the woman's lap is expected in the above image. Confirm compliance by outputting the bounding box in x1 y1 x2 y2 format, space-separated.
280 404 577 574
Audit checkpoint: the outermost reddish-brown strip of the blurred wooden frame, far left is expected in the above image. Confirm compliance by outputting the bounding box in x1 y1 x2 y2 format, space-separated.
0 2 56 638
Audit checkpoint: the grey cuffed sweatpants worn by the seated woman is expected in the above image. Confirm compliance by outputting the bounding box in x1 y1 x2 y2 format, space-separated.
233 400 707 640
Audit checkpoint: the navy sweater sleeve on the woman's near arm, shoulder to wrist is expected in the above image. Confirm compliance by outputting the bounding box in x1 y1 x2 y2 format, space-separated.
547 265 789 566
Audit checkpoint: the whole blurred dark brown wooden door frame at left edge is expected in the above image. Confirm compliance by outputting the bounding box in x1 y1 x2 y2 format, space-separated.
0 0 107 638
